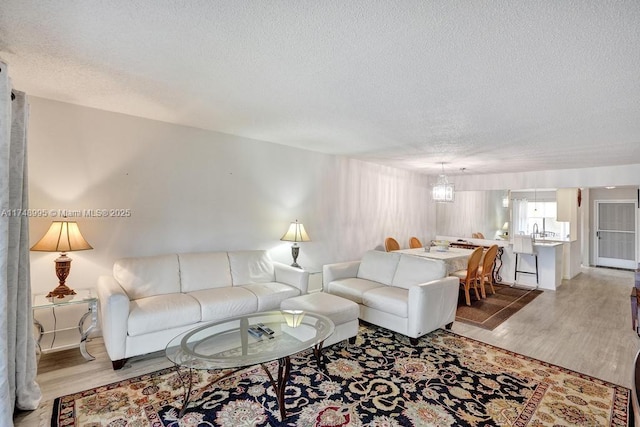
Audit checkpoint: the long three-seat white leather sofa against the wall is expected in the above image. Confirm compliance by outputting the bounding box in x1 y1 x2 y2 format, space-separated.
98 251 309 369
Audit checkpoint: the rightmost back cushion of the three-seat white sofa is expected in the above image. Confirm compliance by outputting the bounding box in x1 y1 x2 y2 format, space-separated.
228 251 275 286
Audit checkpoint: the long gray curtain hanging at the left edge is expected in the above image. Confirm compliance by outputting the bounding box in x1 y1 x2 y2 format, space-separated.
0 61 42 426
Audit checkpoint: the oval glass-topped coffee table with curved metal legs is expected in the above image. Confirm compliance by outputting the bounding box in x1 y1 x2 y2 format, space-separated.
165 310 334 420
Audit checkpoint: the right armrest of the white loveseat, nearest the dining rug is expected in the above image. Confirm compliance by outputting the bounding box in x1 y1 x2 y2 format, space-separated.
407 277 460 338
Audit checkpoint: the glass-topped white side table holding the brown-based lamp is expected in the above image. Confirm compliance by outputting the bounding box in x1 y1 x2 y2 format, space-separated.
32 289 98 360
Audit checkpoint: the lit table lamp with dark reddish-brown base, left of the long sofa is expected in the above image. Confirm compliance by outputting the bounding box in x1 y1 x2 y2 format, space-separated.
31 221 93 298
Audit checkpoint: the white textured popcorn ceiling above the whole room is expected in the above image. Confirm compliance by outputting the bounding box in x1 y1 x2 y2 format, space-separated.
0 0 640 174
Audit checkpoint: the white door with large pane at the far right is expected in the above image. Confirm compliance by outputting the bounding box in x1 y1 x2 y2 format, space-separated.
595 201 638 269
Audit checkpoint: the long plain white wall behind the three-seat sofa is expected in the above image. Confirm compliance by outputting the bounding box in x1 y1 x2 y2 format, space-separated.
29 97 435 293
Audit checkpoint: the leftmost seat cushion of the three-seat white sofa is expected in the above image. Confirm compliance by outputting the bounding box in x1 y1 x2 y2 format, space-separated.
127 293 200 336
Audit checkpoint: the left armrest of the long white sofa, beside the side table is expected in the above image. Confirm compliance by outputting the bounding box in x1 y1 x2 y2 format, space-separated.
98 276 129 361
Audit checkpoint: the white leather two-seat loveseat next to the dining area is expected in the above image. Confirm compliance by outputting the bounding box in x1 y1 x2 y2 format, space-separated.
322 251 460 344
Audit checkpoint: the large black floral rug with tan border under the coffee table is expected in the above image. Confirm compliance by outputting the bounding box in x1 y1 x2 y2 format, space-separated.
51 326 631 427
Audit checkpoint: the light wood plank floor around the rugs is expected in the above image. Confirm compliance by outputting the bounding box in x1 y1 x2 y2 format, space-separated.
14 268 640 427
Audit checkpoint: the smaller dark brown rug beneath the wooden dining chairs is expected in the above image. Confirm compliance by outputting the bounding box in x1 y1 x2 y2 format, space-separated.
456 283 542 331
